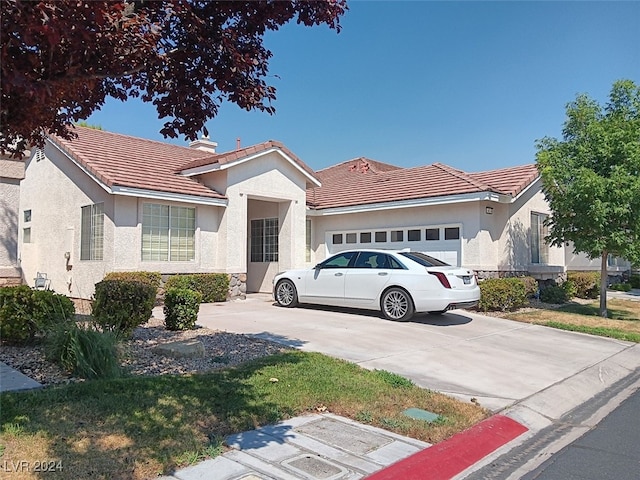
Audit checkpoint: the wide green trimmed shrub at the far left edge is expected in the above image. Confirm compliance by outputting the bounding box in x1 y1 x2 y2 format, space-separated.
0 285 75 344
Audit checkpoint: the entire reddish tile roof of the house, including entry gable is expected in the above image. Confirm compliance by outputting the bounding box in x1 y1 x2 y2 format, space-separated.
50 127 538 209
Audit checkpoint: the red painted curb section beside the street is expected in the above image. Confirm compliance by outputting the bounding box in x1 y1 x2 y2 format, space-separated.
367 415 528 480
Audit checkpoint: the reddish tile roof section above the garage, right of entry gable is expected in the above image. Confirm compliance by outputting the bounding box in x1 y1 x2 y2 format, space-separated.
307 159 538 210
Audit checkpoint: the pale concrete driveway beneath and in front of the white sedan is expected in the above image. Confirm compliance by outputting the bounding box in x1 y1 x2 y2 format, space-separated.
198 294 638 411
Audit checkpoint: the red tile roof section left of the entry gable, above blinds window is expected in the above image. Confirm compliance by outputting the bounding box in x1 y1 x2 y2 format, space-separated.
50 127 225 199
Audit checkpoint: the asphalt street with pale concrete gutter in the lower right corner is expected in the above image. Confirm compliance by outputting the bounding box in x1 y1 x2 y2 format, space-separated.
458 369 640 480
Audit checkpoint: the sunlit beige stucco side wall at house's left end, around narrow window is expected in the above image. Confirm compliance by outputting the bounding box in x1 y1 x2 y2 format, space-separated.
19 144 114 298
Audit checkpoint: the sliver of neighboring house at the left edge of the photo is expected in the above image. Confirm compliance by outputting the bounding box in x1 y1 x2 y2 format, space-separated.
0 152 28 286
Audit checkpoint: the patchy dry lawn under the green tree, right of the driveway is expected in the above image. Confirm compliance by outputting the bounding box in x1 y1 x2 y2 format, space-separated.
502 299 640 342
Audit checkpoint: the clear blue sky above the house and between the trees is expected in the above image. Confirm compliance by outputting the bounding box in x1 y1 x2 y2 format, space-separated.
88 0 640 172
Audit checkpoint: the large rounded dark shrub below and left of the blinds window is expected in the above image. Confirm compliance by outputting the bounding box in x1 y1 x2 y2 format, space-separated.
92 280 157 337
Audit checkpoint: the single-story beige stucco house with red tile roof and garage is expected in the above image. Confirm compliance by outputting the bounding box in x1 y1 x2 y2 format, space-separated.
17 127 629 298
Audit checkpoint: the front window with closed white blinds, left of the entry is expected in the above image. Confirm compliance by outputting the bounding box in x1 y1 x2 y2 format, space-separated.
142 203 196 262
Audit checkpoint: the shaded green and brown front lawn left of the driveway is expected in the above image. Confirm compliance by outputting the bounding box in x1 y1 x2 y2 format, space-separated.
0 351 488 479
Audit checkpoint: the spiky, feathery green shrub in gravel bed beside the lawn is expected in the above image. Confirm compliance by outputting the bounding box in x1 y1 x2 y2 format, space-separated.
46 323 122 379
